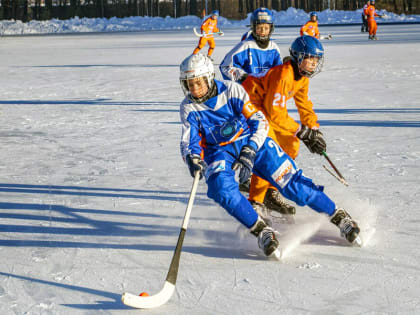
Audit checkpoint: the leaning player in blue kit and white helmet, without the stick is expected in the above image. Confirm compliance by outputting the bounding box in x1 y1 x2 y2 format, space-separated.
180 54 360 257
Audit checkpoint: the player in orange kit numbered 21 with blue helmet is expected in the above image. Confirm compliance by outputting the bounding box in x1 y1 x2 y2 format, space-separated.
242 35 327 221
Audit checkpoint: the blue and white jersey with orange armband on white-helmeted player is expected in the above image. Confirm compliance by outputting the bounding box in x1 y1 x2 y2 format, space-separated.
180 80 268 160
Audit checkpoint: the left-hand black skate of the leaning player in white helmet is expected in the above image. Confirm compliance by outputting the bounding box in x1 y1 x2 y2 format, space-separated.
251 217 281 259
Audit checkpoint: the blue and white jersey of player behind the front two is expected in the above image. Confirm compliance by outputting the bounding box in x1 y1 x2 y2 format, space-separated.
219 33 282 81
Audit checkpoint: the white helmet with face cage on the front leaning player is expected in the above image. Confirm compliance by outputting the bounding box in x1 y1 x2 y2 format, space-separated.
179 53 215 101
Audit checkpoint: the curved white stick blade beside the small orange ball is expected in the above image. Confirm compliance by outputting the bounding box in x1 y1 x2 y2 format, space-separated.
121 281 175 308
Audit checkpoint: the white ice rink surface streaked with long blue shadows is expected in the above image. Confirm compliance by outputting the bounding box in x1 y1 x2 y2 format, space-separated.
0 25 420 315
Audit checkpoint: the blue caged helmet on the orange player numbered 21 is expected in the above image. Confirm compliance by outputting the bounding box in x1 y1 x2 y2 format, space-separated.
289 35 324 78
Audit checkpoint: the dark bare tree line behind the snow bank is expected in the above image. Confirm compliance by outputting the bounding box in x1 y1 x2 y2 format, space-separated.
0 0 420 22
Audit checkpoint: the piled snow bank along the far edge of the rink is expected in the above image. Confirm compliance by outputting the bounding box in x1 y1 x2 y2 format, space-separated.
0 8 420 35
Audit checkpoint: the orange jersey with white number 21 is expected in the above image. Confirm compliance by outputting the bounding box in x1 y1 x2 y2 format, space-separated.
242 61 319 134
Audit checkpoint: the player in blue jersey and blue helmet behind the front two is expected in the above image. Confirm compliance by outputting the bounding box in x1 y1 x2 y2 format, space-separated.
219 8 282 82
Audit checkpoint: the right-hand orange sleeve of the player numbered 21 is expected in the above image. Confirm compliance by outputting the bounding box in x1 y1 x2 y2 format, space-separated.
294 78 319 129
